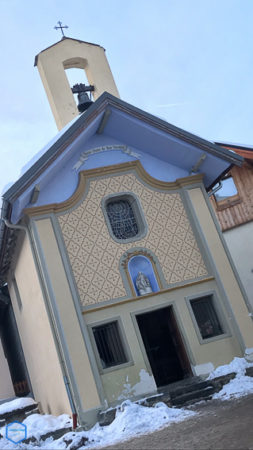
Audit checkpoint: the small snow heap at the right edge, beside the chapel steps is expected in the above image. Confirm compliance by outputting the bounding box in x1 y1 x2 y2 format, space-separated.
208 358 253 400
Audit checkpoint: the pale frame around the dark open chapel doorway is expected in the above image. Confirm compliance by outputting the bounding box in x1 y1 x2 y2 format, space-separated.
130 301 196 387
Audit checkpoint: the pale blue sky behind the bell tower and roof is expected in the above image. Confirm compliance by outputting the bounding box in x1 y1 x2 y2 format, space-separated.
0 0 253 195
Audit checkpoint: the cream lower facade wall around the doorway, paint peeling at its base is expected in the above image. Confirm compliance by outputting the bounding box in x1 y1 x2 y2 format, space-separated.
84 280 242 404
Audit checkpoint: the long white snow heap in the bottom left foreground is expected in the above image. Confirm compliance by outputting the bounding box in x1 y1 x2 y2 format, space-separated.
0 400 196 450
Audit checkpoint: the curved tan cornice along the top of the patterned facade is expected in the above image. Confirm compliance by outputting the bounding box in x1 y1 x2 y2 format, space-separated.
24 160 203 216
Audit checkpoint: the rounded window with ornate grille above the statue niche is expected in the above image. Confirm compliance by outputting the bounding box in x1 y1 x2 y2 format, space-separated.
106 199 139 239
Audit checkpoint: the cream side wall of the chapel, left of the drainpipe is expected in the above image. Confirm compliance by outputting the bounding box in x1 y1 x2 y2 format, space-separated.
8 232 71 414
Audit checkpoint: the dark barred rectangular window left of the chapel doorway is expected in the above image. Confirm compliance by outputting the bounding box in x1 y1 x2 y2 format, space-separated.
92 321 128 369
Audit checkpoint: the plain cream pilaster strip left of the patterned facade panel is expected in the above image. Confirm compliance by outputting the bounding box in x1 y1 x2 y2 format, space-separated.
35 219 100 411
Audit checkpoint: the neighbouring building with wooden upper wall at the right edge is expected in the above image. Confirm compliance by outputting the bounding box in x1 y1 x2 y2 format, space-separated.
210 143 253 305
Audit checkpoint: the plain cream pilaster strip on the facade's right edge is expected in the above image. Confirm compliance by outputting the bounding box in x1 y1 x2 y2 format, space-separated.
189 188 253 349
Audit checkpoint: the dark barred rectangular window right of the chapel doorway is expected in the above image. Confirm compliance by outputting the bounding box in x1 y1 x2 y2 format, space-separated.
191 295 223 339
